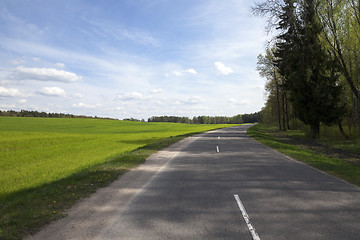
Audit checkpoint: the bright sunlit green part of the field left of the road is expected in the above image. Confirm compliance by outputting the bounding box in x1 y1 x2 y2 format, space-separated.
0 117 232 196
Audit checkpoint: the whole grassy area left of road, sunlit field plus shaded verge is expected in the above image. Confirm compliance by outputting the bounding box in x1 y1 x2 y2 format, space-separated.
0 117 236 239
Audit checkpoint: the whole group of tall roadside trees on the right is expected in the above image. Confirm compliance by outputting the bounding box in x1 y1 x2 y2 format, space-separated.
253 0 360 138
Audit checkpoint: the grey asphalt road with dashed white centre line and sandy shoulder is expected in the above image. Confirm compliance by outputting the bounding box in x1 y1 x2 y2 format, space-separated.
29 126 360 240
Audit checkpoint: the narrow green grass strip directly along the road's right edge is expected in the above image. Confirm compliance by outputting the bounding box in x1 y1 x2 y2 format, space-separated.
247 124 360 186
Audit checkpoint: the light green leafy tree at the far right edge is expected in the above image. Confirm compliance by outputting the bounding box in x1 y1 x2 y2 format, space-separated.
319 0 360 135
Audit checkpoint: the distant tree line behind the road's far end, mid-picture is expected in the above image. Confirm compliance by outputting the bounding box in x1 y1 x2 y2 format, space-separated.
148 112 262 124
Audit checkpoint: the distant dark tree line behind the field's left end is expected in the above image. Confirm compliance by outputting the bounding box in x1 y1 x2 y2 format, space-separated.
0 110 112 119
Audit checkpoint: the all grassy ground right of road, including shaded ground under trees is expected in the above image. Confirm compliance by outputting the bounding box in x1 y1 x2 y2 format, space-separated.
247 124 360 186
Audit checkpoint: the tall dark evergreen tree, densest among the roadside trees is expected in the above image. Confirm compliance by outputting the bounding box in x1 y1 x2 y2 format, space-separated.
276 0 344 138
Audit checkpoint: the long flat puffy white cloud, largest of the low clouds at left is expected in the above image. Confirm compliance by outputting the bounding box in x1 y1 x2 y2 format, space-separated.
10 66 82 82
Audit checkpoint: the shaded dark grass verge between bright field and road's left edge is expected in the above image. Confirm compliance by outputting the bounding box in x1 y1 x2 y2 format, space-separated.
0 132 210 240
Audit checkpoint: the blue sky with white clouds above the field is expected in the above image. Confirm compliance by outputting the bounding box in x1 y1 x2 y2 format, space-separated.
0 0 268 120
